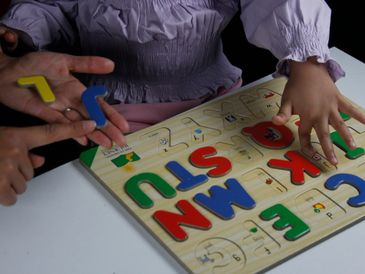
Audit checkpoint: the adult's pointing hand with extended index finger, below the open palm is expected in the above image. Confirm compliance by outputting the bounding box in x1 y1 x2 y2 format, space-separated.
0 121 96 205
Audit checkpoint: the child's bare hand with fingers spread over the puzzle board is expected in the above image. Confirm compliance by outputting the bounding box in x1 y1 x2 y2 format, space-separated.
272 59 365 165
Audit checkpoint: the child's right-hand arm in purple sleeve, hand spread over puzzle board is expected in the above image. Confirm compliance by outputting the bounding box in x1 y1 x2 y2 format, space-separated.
241 0 365 164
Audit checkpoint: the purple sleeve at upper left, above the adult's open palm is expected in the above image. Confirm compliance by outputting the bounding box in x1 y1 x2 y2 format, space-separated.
0 0 77 50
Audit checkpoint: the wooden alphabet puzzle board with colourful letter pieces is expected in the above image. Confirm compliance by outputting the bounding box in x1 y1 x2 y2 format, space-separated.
80 78 365 273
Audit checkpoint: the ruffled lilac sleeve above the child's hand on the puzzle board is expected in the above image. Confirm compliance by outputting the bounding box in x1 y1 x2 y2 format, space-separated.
241 0 345 81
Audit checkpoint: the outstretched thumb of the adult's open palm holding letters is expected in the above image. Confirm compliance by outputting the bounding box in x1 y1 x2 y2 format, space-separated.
65 54 114 74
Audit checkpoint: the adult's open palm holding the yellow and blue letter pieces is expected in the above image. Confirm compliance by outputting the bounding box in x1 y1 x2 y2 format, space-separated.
0 52 129 147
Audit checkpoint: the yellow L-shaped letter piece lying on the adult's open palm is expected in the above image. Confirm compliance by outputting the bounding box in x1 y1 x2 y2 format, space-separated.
17 75 56 103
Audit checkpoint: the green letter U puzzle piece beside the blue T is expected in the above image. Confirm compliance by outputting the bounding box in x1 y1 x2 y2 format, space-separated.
124 172 176 208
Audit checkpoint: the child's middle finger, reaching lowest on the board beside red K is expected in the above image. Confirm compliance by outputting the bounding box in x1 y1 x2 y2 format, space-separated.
314 119 337 165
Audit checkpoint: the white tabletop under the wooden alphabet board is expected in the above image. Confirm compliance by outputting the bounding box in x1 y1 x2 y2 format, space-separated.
0 48 365 274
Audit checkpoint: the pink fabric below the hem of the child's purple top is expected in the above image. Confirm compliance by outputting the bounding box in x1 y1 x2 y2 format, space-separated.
113 79 242 133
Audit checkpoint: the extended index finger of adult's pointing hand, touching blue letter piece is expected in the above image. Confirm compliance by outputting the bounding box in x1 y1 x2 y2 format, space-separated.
22 121 96 149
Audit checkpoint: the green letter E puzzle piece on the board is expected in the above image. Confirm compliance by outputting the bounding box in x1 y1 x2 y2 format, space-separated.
260 204 310 241
